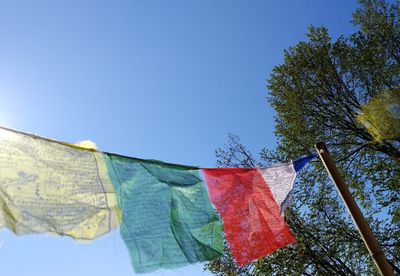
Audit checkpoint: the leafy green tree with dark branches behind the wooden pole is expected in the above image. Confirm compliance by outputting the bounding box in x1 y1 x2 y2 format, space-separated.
206 0 400 275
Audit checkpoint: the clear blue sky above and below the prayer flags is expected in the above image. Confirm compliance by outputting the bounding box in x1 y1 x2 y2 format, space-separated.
0 0 356 276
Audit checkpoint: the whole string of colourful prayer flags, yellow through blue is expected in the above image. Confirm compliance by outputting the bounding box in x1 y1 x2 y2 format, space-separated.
0 127 312 273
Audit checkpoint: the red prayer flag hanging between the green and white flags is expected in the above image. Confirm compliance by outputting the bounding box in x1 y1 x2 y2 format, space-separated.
203 168 296 266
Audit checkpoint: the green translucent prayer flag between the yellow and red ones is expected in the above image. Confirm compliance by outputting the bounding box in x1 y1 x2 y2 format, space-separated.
104 154 223 272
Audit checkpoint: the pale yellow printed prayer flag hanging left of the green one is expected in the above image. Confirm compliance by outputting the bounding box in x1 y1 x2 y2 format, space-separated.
0 128 119 240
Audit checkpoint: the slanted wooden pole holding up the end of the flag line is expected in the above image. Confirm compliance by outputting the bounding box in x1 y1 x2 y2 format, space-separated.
315 142 394 276
